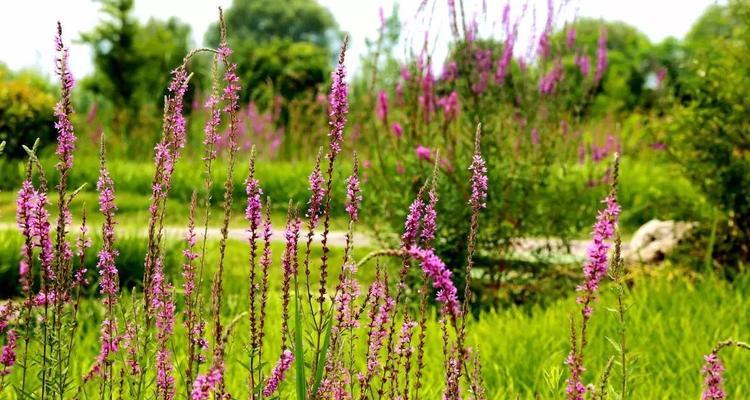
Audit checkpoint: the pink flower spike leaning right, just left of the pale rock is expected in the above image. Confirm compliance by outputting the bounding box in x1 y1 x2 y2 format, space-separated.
576 195 620 318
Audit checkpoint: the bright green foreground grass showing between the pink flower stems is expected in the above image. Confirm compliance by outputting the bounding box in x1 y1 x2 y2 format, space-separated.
2 231 750 399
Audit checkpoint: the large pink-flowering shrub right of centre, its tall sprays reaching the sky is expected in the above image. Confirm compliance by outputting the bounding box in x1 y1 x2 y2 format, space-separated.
353 1 621 306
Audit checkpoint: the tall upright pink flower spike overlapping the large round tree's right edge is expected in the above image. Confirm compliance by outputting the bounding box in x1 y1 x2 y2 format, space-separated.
328 38 349 159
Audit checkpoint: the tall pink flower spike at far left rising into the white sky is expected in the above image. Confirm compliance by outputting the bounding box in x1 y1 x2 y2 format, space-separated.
55 22 76 173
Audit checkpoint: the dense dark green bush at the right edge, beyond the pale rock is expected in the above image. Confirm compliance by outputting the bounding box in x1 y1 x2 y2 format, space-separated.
666 1 750 265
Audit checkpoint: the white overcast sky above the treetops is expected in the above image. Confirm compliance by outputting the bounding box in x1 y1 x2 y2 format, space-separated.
0 0 721 81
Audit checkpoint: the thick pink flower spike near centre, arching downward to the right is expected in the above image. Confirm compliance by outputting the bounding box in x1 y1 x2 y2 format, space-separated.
407 246 460 318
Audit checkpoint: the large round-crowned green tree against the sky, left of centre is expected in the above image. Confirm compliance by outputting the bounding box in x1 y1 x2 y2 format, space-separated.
205 0 337 100
